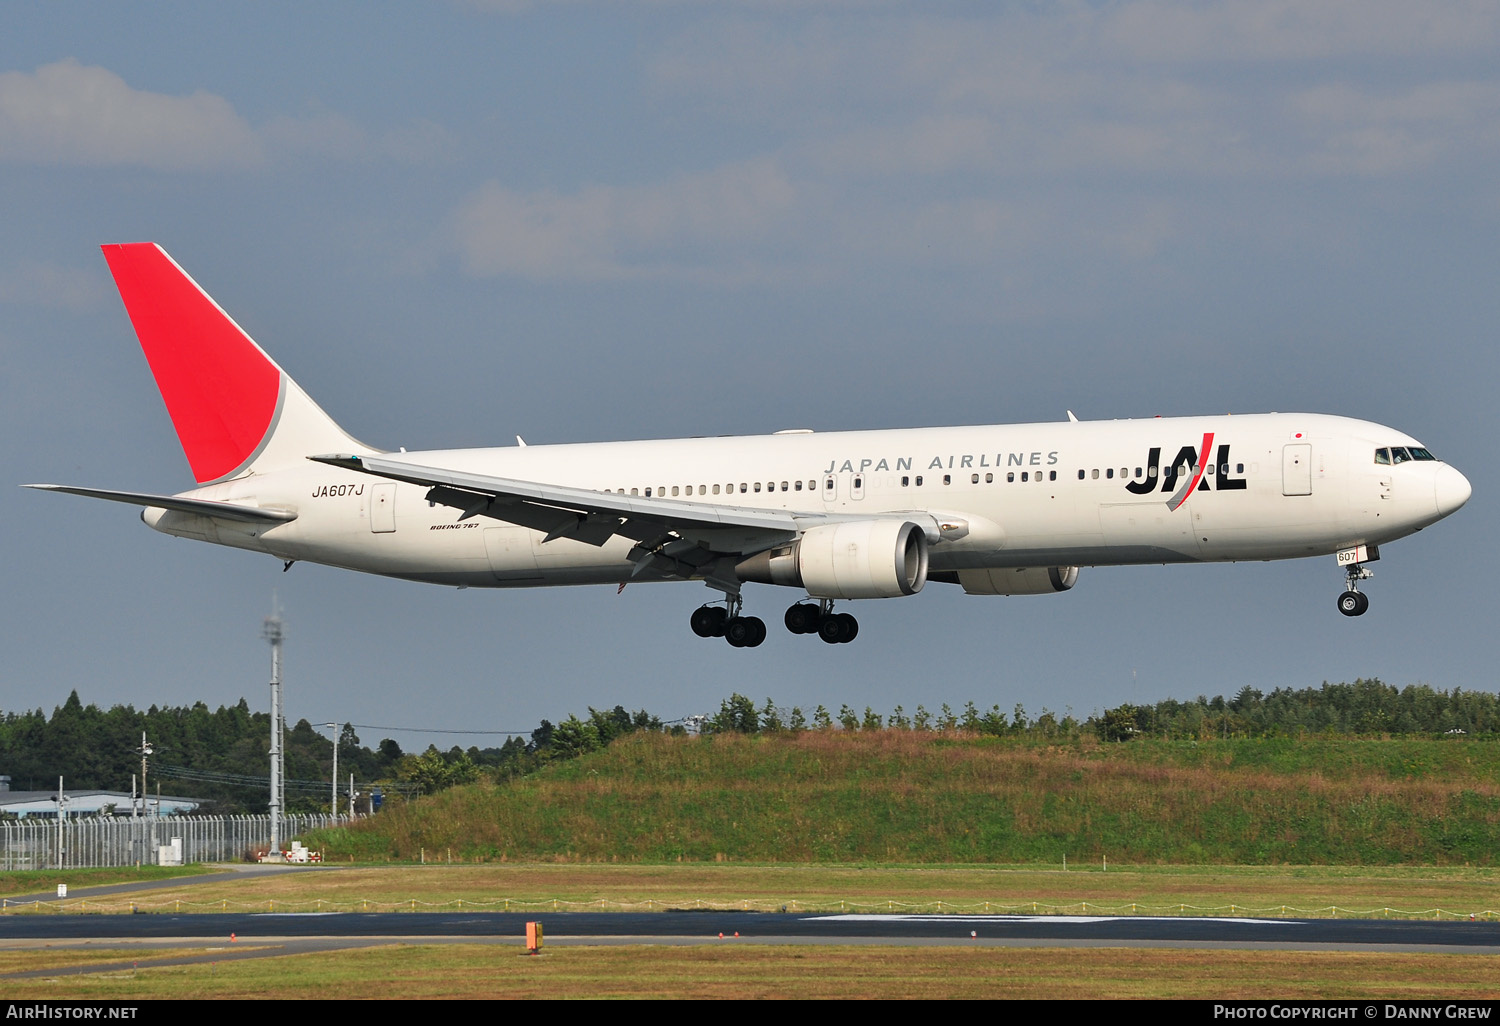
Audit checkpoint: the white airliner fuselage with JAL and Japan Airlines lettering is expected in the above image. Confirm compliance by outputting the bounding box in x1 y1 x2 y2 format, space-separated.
144 414 1469 587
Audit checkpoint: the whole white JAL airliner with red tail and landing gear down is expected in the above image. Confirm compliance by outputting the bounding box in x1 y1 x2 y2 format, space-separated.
30 243 1470 648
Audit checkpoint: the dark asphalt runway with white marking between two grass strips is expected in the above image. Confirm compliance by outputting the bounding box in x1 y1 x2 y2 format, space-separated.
0 911 1500 954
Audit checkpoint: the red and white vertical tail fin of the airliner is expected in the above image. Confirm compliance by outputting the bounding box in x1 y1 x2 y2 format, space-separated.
102 243 375 485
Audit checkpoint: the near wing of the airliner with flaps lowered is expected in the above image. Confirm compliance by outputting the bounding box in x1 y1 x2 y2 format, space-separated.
309 455 855 590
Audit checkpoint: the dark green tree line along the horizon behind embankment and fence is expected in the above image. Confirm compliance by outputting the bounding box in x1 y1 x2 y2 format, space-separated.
0 678 1500 813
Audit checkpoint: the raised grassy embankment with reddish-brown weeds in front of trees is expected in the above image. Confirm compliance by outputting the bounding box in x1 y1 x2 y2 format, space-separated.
309 731 1500 866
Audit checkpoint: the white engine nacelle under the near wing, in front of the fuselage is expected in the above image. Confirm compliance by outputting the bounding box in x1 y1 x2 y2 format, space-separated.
735 521 927 599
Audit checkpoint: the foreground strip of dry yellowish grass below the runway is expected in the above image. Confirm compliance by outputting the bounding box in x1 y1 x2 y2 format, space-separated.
0 942 1500 1001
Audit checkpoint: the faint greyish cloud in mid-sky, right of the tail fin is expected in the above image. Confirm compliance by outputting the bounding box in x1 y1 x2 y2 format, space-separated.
452 159 797 279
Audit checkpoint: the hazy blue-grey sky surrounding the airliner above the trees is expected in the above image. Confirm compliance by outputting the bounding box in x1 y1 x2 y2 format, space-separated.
0 0 1500 747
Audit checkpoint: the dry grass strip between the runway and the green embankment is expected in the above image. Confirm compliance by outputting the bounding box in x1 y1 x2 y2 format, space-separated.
11 863 1500 918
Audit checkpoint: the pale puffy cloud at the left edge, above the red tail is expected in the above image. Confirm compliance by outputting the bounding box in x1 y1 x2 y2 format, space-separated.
0 59 264 171
